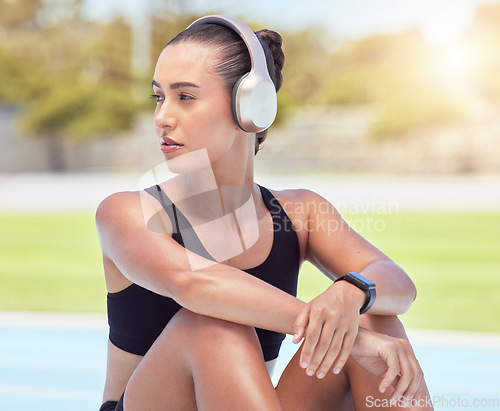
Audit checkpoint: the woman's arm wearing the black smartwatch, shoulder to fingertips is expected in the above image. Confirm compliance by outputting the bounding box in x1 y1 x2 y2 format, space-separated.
284 190 416 375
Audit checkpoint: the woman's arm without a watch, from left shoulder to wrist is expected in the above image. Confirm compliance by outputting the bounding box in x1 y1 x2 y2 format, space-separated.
96 192 305 334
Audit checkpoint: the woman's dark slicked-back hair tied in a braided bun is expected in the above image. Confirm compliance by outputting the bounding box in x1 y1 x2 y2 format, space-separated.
167 23 285 154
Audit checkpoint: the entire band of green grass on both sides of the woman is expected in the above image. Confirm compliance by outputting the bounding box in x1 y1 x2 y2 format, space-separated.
0 213 500 332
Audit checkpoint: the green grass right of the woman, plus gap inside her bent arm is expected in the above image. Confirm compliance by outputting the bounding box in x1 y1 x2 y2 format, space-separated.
300 214 500 332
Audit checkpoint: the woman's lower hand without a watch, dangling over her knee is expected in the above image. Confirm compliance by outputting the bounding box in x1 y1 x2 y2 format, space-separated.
351 327 424 401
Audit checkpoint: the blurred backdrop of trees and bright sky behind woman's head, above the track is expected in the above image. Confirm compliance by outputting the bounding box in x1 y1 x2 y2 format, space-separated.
0 0 500 173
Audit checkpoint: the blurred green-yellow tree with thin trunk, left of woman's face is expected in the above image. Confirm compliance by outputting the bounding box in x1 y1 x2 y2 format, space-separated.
0 0 135 171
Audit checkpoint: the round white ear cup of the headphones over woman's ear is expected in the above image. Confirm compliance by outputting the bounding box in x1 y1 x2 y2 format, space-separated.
231 72 277 133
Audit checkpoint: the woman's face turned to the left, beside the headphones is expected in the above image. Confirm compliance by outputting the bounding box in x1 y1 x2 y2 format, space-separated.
152 42 241 171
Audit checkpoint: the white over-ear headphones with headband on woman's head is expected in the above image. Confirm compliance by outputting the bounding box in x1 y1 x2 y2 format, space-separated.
188 15 277 133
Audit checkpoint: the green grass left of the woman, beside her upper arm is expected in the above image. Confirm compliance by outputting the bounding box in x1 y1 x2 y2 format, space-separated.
0 213 106 312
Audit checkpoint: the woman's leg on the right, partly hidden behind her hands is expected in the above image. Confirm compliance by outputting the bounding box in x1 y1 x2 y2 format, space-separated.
276 315 432 411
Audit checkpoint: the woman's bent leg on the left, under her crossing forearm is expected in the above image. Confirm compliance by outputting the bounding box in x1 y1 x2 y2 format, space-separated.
124 309 281 411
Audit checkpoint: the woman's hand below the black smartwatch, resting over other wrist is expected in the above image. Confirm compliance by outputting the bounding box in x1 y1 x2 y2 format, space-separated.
293 281 366 378
